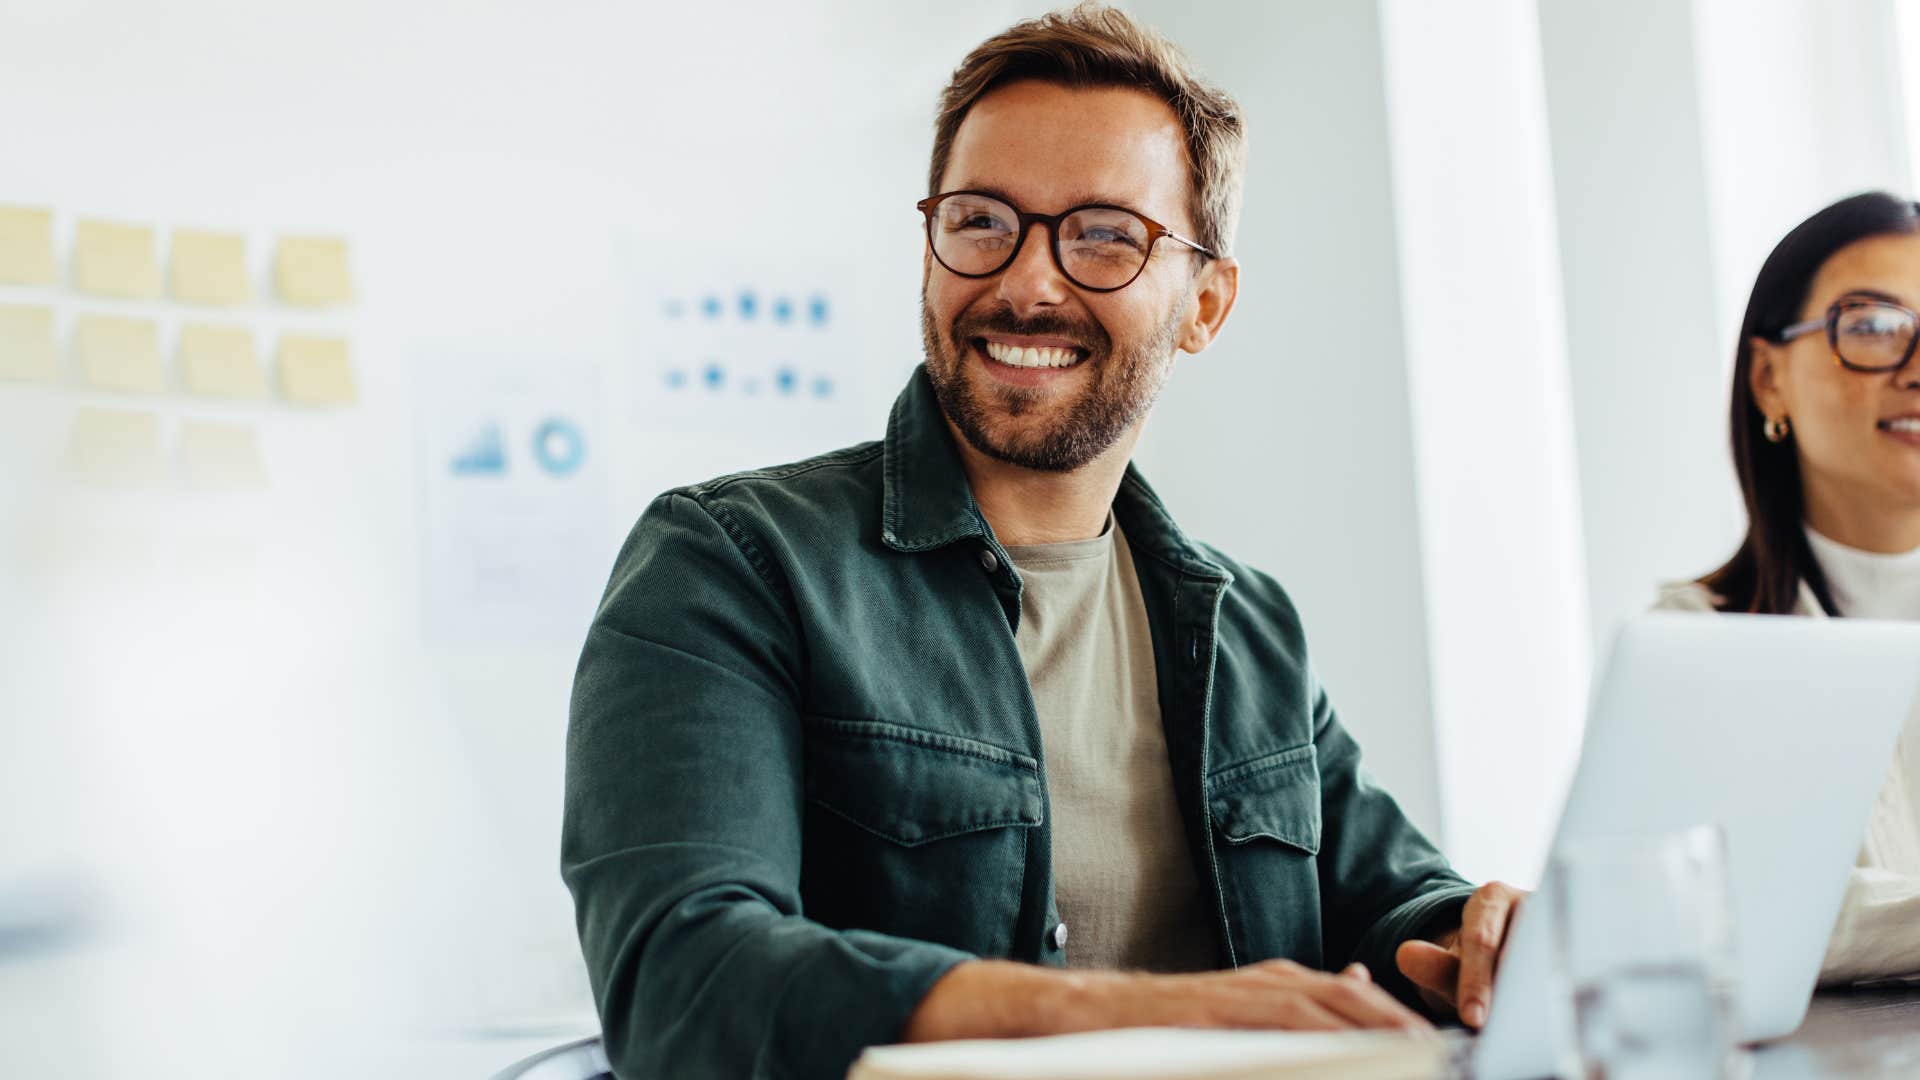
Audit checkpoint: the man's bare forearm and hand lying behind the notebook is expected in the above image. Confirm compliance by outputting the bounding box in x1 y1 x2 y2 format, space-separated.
900 961 1432 1042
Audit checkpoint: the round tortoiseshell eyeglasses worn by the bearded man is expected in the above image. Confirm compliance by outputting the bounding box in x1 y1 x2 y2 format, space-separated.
914 192 1219 292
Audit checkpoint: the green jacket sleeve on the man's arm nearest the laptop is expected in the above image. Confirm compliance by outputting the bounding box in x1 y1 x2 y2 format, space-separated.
1313 682 1473 1009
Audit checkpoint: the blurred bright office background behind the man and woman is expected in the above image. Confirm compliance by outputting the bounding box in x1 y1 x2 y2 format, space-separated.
0 0 1920 1076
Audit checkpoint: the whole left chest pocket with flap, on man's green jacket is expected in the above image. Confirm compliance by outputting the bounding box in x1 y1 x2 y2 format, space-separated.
801 717 1043 955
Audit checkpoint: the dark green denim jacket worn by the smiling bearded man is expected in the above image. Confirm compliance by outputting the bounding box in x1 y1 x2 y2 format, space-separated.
561 369 1471 1078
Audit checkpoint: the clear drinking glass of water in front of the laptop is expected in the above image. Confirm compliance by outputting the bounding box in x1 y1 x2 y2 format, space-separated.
1548 824 1747 1080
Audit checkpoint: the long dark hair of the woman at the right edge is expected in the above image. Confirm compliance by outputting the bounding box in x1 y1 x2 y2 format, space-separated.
1699 192 1920 615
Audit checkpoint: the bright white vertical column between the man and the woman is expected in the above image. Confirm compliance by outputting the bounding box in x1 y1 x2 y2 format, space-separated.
1380 0 1588 884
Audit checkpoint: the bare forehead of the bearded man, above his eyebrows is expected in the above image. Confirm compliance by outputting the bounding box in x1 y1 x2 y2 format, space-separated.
941 81 1190 225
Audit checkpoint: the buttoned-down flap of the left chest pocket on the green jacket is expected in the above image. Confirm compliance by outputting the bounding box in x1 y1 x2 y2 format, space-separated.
806 717 1043 847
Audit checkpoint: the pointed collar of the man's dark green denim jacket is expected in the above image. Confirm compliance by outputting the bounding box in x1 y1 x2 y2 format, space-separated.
879 363 1233 582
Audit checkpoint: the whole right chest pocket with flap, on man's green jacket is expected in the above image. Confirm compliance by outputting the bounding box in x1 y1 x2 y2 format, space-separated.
1206 744 1321 965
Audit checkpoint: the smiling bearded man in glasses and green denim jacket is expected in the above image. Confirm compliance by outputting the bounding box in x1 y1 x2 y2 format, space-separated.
563 6 1519 1076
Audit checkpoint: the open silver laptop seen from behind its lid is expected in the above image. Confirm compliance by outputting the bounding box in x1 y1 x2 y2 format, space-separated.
1473 615 1920 1080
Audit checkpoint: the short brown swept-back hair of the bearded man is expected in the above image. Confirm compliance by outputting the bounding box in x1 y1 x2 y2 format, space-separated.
927 2 1246 256
